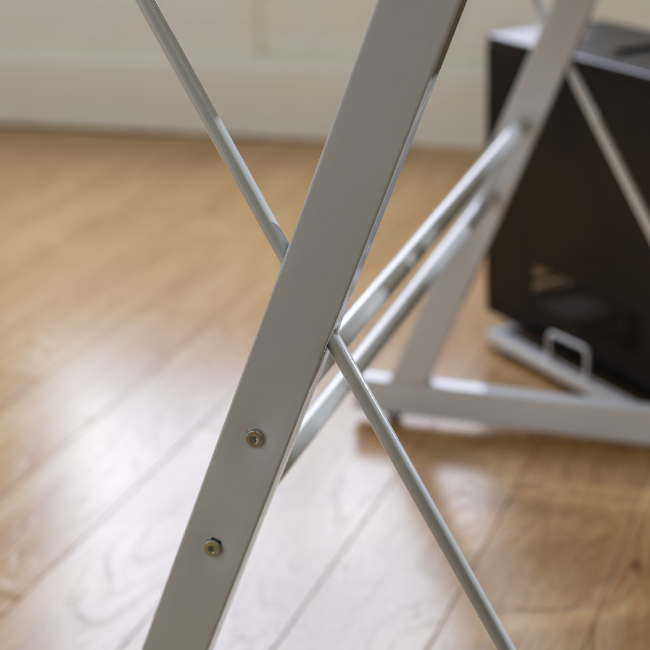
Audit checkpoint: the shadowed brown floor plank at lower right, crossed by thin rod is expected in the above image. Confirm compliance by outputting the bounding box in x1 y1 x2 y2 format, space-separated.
430 439 649 650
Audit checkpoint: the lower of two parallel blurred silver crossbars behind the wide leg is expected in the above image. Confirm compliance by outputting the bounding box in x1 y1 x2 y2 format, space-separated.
285 194 491 471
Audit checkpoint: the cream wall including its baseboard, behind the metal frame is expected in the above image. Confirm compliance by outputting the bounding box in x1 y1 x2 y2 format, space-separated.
0 0 650 147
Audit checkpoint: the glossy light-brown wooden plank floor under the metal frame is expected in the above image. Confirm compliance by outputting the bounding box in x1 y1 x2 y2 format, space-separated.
0 128 650 650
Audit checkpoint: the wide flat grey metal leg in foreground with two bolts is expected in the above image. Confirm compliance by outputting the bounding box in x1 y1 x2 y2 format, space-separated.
140 0 464 650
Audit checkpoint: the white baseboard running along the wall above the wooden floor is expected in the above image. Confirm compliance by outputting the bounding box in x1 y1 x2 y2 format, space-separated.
0 57 485 149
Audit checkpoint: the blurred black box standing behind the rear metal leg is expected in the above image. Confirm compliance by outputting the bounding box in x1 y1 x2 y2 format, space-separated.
489 23 650 390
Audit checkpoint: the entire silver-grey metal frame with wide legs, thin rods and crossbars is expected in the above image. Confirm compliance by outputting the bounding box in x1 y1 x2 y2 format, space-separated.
132 0 650 650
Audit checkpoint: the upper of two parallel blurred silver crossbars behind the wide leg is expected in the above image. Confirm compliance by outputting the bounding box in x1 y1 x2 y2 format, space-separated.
340 125 522 352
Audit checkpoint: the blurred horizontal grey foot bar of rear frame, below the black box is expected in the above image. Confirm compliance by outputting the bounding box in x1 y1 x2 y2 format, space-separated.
364 368 650 446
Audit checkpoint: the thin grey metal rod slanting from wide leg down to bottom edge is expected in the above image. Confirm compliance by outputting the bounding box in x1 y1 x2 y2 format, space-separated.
328 332 515 650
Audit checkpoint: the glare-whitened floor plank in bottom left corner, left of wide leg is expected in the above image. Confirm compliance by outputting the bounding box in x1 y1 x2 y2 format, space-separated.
0 416 217 650
